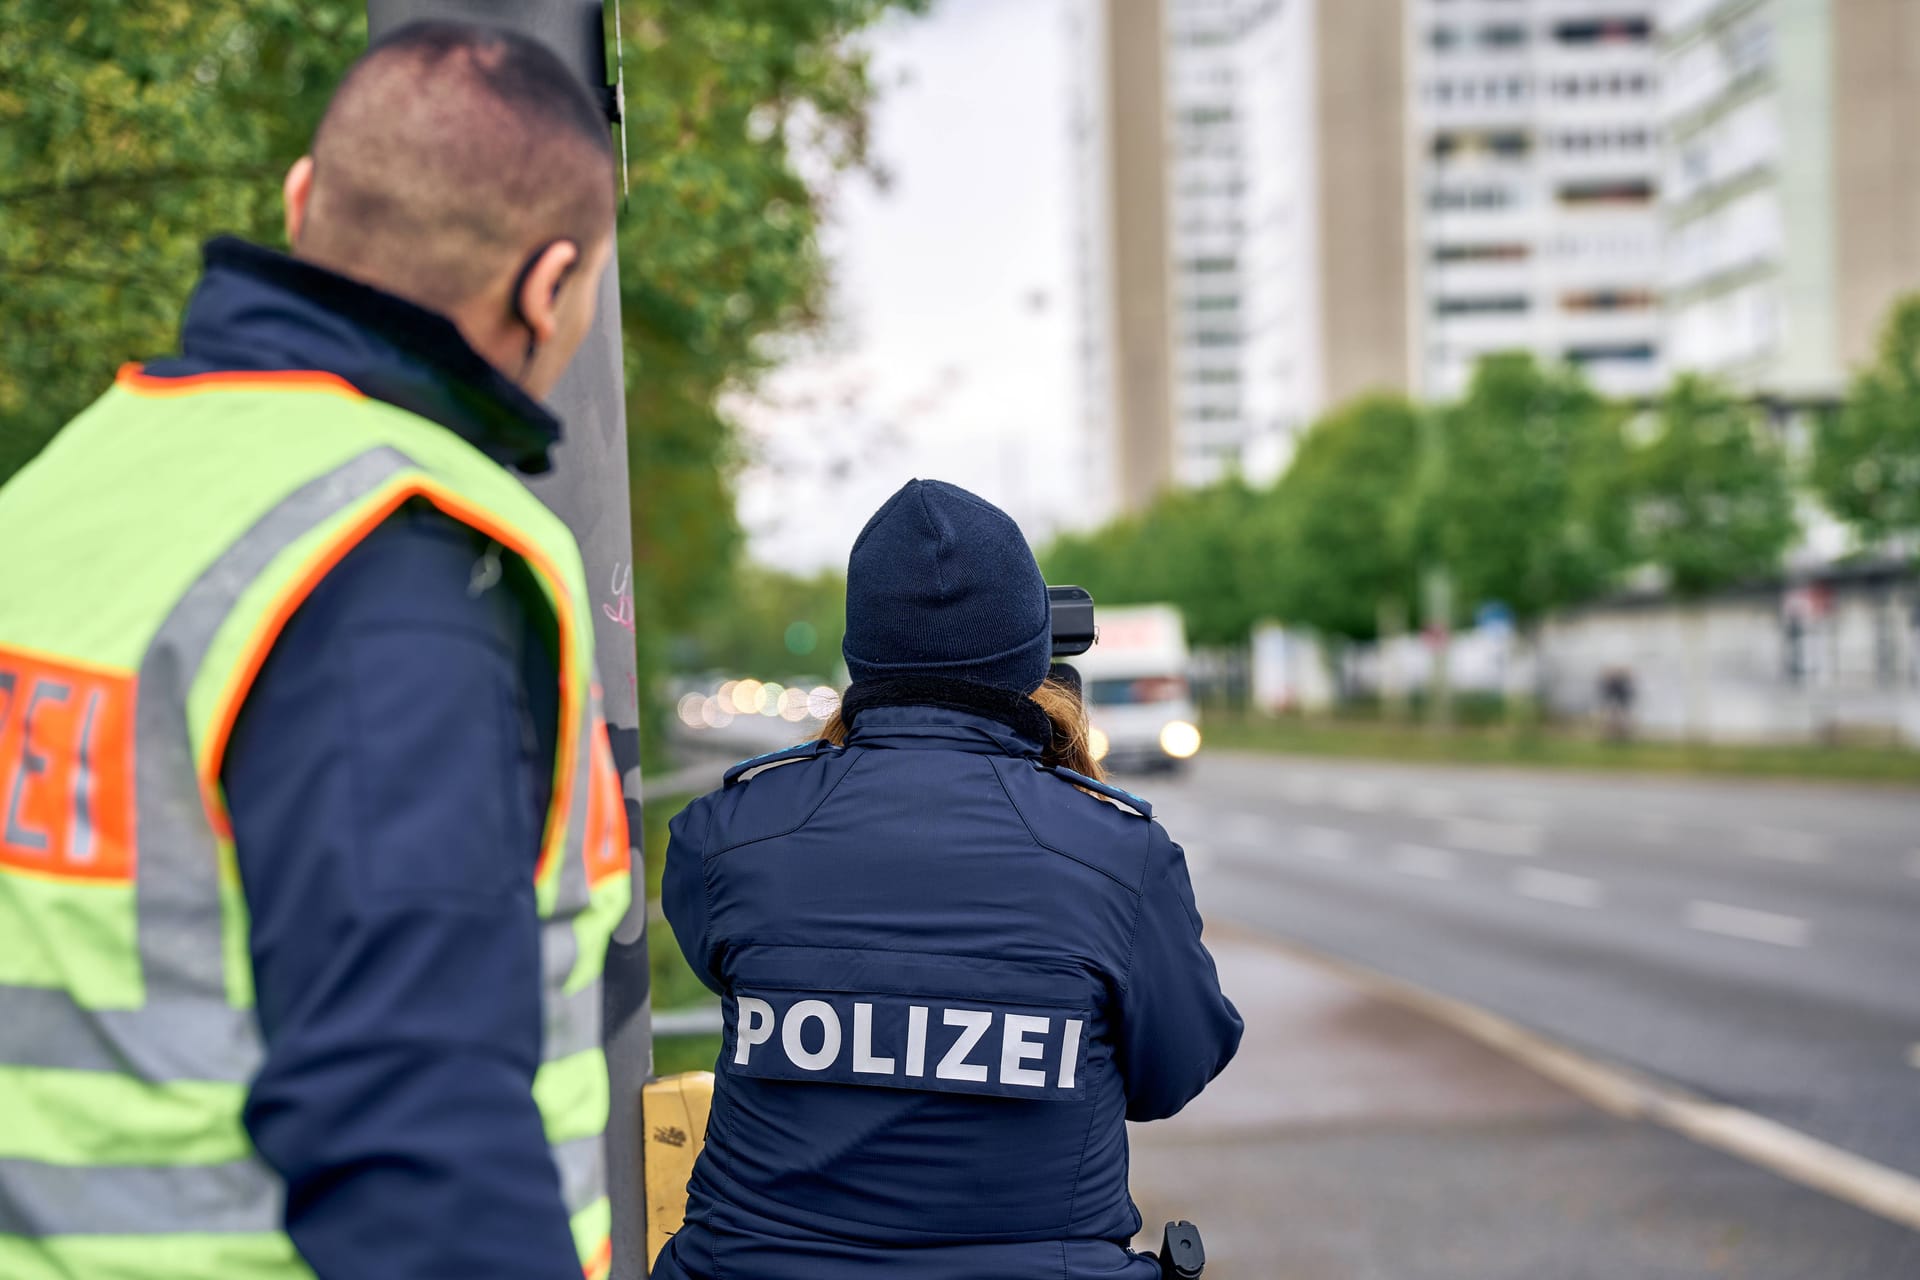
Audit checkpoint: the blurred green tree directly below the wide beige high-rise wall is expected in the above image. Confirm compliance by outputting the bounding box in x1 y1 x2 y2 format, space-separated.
1271 395 1421 641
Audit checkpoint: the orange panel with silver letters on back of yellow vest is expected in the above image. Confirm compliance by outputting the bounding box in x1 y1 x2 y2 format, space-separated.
0 645 134 883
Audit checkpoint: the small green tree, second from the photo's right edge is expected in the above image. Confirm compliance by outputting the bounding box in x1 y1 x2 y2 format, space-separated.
1628 376 1797 599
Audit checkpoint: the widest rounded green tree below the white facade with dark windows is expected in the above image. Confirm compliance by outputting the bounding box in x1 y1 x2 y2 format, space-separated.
1415 353 1626 628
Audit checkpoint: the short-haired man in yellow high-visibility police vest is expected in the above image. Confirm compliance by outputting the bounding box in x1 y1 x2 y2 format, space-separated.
0 23 628 1280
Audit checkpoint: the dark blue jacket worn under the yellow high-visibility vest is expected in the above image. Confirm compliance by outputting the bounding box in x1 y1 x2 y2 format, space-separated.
148 240 580 1280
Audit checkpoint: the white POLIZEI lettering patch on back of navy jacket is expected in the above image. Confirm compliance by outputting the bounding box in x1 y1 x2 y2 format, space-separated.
720 990 1089 1102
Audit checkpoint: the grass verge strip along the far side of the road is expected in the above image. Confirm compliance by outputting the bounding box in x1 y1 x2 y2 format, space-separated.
1206 714 1920 787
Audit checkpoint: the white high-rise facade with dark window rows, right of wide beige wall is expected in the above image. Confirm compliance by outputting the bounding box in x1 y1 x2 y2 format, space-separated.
1407 0 1663 397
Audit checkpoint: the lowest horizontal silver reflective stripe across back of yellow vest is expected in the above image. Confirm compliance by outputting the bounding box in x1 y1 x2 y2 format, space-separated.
0 1159 284 1236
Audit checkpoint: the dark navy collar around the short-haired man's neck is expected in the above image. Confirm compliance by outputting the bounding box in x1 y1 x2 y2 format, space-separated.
146 236 561 474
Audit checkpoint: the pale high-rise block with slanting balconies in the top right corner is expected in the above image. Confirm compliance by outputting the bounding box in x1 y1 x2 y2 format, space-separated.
1661 0 1920 397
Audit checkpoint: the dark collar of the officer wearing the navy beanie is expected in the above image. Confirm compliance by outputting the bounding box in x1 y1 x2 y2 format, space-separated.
841 676 1052 756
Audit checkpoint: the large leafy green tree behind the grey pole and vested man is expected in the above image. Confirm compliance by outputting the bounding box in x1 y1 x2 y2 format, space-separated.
0 0 927 759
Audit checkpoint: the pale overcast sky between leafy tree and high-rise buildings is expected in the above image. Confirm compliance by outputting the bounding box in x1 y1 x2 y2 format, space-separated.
739 0 1079 570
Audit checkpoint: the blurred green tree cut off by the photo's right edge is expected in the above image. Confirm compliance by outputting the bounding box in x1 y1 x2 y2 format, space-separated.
1811 296 1920 545
